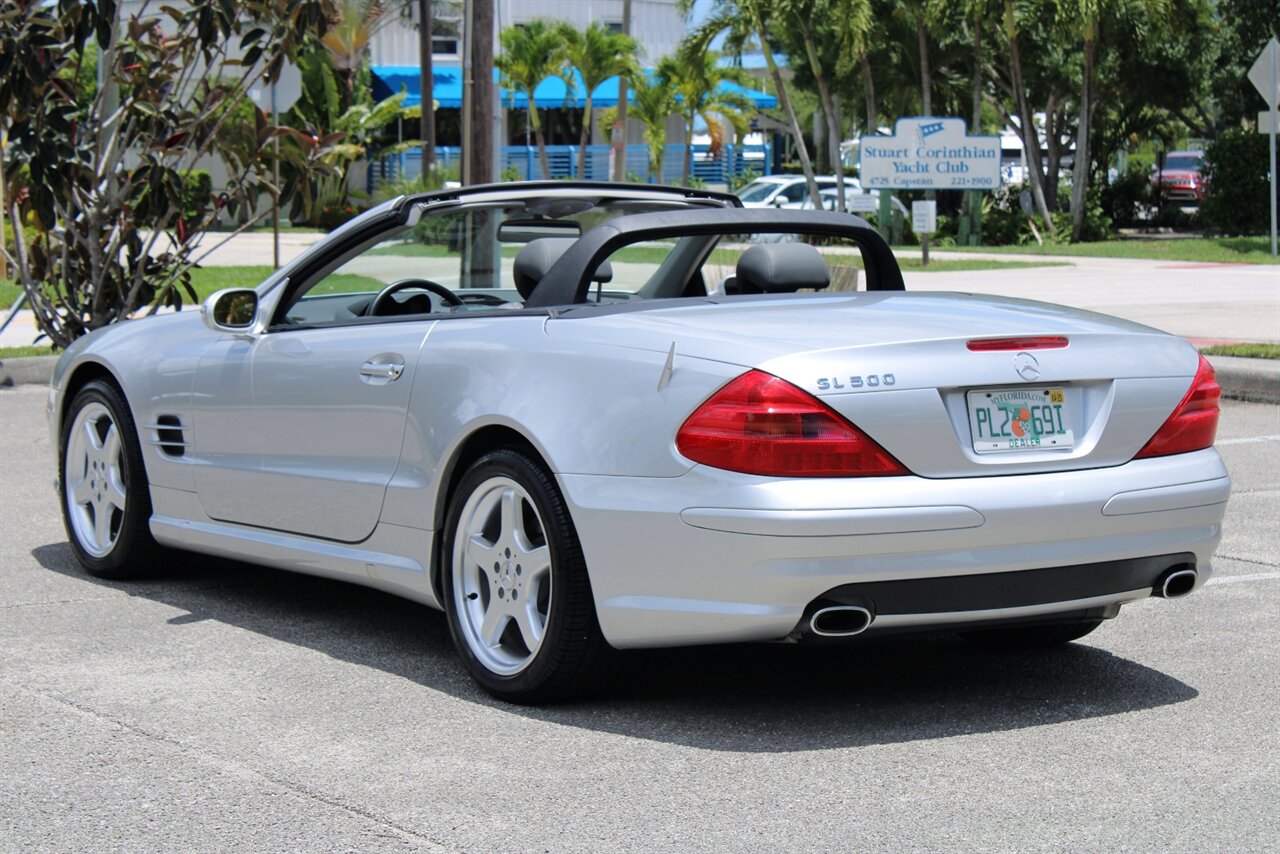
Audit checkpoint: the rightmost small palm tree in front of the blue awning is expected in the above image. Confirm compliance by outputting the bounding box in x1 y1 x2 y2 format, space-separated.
658 44 755 184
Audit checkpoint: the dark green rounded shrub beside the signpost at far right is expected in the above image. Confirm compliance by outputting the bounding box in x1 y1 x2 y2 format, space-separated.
1199 128 1271 234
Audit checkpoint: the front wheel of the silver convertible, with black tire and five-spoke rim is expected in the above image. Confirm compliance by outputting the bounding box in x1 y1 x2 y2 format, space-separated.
58 379 160 579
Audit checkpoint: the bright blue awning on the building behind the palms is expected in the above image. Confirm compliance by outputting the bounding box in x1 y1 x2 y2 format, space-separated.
372 64 778 110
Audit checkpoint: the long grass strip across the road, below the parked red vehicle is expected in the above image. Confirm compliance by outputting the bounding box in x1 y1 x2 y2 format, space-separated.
942 237 1280 264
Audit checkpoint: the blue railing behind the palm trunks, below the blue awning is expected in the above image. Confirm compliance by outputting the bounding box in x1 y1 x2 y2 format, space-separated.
367 145 773 193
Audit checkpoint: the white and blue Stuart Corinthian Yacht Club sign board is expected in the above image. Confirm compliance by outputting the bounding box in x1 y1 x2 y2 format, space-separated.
859 117 1000 189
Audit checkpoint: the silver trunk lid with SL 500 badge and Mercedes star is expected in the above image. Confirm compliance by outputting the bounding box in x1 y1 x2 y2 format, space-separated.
547 293 1198 478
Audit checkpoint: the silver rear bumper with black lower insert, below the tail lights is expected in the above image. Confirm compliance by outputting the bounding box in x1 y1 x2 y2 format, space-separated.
561 449 1230 648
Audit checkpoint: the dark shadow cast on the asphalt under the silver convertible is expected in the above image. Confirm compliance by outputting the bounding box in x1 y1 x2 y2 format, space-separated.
32 543 1198 753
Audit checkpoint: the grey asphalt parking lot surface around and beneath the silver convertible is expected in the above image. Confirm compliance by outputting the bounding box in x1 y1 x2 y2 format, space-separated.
0 385 1280 851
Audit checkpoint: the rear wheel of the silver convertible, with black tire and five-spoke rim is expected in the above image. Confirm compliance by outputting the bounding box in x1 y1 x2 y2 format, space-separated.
440 449 617 704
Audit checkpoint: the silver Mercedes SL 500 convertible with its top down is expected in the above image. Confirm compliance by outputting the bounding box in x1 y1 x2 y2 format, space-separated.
49 182 1230 703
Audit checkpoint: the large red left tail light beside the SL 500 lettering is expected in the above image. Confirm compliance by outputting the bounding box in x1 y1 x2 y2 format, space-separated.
676 370 910 478
